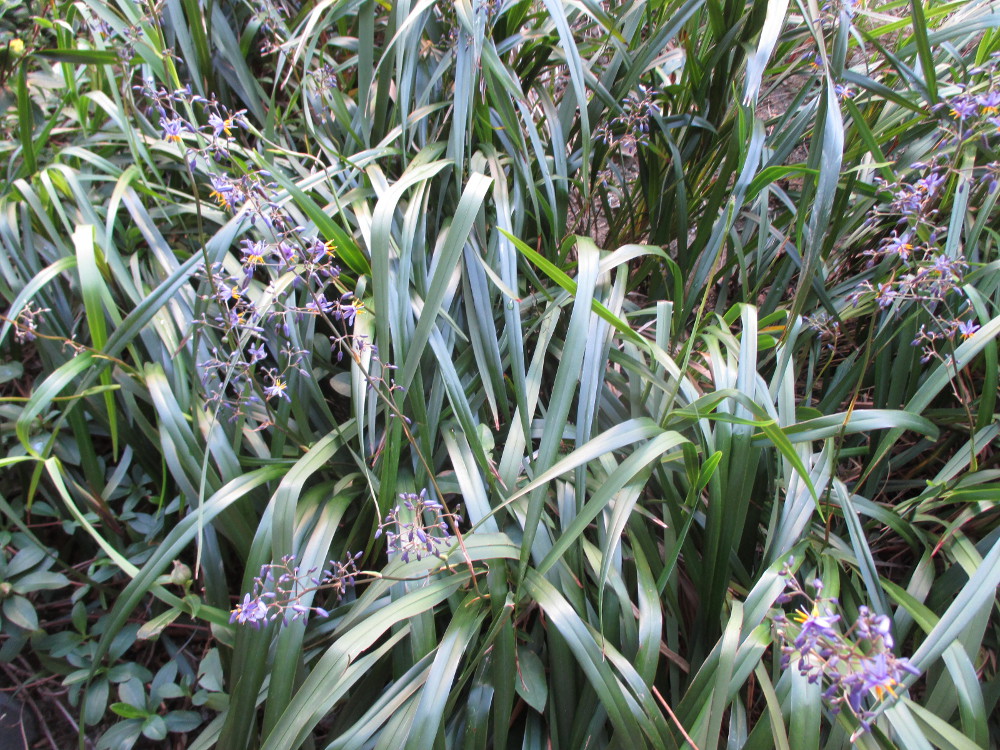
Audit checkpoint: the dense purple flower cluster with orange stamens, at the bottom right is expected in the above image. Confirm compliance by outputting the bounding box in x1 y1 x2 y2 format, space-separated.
772 560 920 740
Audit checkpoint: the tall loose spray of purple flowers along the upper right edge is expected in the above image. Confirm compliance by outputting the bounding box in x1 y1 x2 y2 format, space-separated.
824 41 1000 370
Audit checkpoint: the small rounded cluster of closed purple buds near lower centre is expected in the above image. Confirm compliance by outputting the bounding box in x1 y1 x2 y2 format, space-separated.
375 489 462 562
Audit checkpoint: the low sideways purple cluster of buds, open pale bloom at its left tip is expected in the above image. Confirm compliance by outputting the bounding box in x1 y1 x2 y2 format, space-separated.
229 552 361 629
